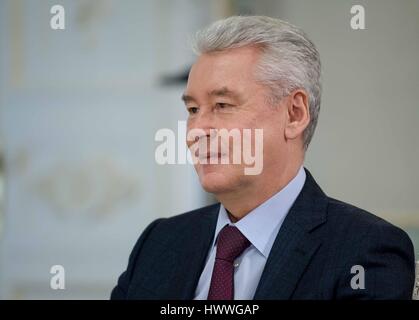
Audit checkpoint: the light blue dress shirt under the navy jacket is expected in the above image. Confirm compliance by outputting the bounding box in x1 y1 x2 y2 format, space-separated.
195 166 306 300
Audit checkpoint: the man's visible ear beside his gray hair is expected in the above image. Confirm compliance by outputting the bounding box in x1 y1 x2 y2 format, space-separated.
285 89 310 139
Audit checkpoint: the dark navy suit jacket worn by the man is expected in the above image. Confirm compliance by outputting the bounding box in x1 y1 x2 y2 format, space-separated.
111 169 415 299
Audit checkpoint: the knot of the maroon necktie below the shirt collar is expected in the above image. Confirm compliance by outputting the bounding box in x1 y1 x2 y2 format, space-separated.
216 225 250 262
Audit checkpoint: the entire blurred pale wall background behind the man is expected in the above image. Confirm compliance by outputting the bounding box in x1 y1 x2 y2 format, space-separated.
0 0 419 299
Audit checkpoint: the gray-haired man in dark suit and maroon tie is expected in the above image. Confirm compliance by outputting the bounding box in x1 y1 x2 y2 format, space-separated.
111 16 414 300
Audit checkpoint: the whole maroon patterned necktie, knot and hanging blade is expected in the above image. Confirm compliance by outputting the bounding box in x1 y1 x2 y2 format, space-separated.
208 225 250 300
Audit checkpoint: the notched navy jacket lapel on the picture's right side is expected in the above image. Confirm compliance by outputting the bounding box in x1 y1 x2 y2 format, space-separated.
254 169 328 300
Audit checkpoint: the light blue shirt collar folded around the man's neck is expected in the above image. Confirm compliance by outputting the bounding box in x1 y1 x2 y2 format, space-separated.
214 166 306 258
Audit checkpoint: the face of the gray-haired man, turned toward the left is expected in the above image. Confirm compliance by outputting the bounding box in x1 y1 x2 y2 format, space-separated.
183 47 286 195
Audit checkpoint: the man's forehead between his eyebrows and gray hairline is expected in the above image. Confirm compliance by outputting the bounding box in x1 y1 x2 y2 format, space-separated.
187 47 260 93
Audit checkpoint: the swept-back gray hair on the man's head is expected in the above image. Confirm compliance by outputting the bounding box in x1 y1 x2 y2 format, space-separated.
193 16 321 150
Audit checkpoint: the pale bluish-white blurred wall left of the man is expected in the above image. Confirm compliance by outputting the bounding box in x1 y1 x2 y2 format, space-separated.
0 0 215 299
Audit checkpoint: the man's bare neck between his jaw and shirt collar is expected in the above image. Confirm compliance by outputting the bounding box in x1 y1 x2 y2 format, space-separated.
216 161 302 222
